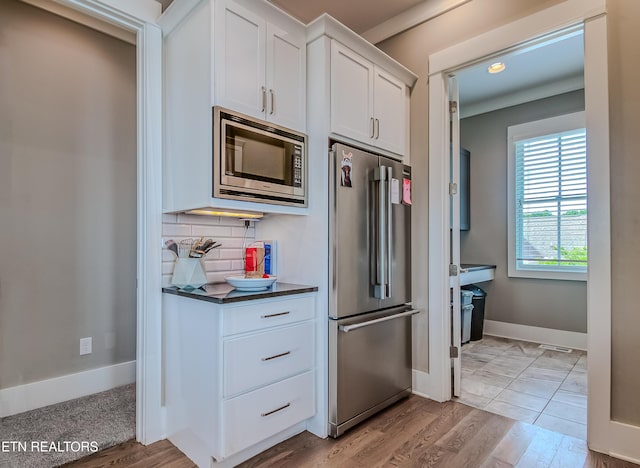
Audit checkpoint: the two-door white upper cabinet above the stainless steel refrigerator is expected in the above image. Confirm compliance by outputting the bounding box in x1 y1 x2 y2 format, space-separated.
331 40 409 156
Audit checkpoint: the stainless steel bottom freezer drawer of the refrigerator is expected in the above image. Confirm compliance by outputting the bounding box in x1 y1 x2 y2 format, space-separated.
329 307 418 437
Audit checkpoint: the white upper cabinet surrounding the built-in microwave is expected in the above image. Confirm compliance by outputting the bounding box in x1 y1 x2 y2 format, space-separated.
159 0 307 214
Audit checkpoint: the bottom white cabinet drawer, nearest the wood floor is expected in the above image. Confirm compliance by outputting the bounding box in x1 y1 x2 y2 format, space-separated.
222 372 315 457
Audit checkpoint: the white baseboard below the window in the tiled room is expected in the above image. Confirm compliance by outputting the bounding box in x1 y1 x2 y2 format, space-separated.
484 320 587 351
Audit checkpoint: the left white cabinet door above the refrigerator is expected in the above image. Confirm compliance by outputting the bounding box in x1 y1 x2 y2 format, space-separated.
331 41 373 143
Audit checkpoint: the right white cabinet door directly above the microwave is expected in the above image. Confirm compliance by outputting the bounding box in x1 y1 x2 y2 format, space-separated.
266 23 307 132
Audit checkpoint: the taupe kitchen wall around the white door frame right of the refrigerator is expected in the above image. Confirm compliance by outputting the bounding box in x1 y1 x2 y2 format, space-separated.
378 0 640 425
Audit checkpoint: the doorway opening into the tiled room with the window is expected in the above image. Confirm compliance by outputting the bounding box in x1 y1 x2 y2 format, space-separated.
449 27 587 439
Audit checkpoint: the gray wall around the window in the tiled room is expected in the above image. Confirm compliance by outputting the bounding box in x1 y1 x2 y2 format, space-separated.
460 90 587 333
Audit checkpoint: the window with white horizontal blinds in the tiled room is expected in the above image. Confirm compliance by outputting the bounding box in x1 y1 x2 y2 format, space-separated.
515 128 587 272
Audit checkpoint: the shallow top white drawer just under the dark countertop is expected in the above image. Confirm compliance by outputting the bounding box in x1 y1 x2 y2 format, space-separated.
222 296 315 336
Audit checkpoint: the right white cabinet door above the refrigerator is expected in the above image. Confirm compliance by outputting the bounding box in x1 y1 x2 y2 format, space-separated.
373 67 407 154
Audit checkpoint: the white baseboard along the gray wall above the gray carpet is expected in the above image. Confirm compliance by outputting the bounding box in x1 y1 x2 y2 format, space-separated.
0 361 136 417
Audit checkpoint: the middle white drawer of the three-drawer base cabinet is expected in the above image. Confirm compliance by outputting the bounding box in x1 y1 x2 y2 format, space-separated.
223 322 314 397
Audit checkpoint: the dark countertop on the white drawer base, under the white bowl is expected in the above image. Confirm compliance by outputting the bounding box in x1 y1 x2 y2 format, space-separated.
162 282 318 304
